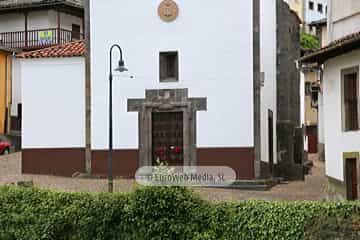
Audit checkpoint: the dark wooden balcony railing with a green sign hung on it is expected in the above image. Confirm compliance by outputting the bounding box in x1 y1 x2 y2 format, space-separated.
0 28 84 49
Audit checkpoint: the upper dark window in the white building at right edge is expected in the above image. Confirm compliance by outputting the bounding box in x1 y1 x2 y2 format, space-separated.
343 67 359 131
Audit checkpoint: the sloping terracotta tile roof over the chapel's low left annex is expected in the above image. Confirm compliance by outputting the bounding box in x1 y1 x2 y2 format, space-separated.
16 40 86 58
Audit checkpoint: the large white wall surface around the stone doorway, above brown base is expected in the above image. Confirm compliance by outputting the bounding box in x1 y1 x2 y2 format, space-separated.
90 0 254 149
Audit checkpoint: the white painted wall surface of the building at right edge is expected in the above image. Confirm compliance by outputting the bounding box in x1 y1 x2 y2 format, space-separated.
321 0 360 186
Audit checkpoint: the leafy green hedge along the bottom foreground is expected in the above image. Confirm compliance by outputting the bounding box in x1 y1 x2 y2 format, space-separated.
0 187 360 240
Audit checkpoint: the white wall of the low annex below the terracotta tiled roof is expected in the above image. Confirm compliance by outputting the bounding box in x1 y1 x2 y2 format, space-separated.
20 58 85 149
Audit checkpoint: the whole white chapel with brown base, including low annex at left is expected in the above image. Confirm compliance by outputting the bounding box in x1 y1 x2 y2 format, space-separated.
20 0 295 179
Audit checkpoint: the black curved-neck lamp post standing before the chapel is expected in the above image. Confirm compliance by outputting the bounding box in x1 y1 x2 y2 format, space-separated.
108 44 128 193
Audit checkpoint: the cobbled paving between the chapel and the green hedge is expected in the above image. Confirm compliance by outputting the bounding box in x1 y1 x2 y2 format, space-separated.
0 153 326 202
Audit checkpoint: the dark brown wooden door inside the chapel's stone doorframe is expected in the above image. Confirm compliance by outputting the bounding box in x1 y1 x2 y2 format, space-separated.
151 112 184 166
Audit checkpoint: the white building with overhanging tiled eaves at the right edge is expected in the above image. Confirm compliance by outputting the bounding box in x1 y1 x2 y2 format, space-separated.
302 0 360 200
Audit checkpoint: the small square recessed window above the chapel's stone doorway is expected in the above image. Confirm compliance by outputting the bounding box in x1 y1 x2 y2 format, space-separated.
160 52 179 82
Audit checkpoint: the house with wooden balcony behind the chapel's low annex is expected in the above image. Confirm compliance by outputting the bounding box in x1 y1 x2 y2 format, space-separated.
0 0 84 148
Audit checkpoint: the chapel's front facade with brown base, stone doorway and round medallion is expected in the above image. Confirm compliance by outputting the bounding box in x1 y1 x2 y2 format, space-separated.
90 0 275 179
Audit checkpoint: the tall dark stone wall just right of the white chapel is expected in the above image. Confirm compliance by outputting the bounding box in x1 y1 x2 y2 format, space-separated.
277 0 302 179
